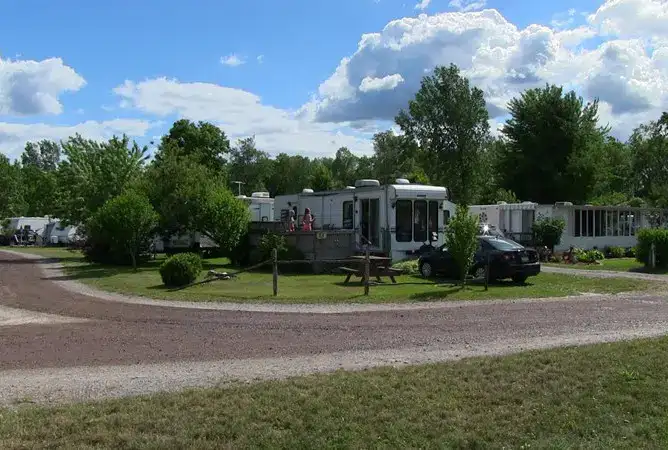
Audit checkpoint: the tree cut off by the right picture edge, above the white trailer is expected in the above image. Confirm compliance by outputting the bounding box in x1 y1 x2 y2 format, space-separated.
628 112 668 208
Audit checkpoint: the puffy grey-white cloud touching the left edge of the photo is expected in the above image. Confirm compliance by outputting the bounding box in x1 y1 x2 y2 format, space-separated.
0 58 86 116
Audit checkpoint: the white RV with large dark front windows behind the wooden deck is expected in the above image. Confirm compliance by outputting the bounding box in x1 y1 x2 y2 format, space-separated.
274 178 455 261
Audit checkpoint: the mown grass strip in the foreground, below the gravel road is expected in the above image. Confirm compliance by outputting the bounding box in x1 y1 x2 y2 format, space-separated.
0 338 668 449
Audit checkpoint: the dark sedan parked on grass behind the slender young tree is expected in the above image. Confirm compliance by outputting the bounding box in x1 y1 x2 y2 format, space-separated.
418 236 540 283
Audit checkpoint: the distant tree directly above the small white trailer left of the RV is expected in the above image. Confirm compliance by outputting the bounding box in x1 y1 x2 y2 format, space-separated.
229 137 273 195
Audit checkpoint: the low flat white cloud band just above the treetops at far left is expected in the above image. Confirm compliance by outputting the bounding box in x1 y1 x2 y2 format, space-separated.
0 119 159 159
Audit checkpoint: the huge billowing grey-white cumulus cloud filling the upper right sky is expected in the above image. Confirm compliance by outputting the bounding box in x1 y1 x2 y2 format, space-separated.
303 0 668 139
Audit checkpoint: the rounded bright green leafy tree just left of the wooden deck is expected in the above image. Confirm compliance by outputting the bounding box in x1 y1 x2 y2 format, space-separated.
197 187 250 252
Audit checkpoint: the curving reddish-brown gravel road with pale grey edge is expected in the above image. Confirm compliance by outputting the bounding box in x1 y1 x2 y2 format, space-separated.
0 252 668 404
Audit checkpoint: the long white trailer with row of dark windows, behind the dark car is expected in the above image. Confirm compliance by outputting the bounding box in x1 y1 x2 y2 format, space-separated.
469 202 668 251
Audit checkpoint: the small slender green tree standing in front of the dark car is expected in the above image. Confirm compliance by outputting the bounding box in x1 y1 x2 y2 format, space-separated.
445 205 480 285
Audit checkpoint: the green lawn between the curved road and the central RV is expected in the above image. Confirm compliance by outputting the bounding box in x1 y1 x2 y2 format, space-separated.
3 248 664 303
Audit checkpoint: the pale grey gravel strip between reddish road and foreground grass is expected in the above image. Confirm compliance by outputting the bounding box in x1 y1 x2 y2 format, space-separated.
0 327 667 406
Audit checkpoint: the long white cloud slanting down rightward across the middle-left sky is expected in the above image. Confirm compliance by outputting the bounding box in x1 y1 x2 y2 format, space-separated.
114 78 371 155
